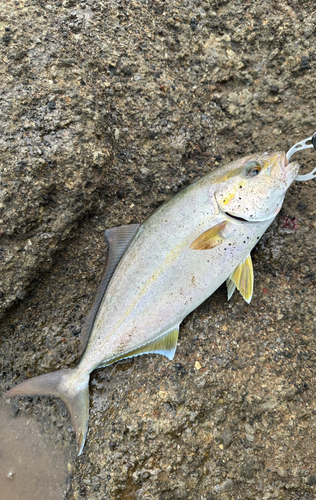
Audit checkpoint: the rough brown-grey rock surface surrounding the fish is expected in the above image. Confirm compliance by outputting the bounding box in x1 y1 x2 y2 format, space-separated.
0 0 316 500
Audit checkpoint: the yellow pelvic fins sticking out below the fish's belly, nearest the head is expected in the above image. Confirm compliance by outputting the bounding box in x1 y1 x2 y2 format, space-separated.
226 254 253 304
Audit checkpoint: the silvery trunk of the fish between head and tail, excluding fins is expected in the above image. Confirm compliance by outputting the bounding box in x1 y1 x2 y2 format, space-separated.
82 178 273 370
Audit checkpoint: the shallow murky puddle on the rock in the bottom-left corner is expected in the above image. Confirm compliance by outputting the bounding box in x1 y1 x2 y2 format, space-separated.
0 400 71 500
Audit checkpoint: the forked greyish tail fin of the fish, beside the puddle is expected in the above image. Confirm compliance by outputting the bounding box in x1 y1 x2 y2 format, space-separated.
5 370 89 455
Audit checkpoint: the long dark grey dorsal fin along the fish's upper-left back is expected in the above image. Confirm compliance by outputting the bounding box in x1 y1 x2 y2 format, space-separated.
80 224 140 354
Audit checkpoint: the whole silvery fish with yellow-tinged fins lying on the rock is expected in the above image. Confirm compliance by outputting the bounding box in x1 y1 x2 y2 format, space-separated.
6 147 299 455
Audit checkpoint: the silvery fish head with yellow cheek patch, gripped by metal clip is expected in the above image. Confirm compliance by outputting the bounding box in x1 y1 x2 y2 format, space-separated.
214 152 299 222
